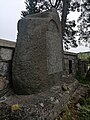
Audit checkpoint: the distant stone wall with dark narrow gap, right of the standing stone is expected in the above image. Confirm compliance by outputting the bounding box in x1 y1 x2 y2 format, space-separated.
64 51 88 76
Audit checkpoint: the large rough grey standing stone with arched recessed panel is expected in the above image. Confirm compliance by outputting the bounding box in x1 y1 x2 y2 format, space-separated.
12 10 63 94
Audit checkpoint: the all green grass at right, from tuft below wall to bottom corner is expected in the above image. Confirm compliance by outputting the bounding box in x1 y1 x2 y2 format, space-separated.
57 72 90 120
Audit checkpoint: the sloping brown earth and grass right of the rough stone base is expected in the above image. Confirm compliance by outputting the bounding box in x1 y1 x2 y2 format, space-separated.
56 84 90 120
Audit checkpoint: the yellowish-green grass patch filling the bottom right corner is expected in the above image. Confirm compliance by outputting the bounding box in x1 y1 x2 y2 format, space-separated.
56 91 90 120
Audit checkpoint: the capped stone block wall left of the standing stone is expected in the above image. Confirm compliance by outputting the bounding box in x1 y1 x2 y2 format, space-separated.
0 39 15 94
